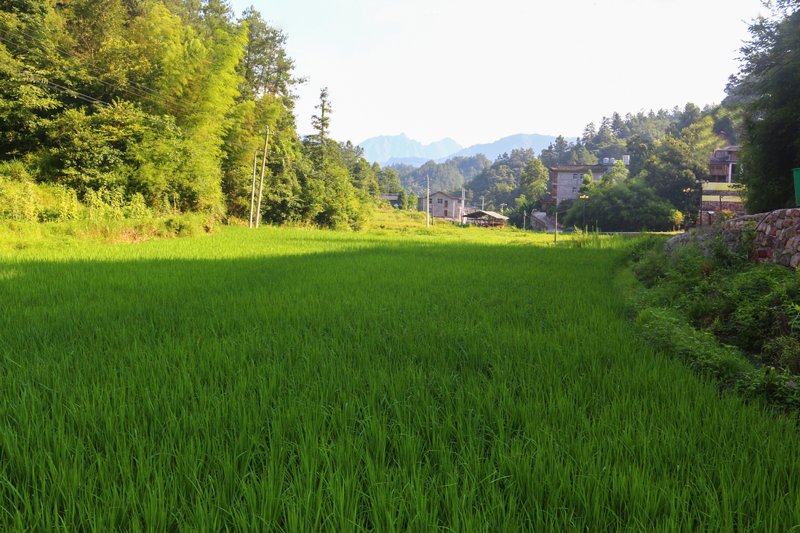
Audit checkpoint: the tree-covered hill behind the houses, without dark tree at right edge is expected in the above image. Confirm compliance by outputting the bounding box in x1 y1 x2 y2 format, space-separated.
393 103 742 230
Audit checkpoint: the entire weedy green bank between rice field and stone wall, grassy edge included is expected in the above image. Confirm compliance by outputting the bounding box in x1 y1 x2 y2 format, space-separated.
629 233 800 410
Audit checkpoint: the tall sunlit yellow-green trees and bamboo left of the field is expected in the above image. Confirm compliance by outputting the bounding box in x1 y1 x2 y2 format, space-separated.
0 0 397 227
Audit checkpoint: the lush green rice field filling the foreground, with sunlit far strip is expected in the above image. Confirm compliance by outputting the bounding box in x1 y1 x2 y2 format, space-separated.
0 223 800 531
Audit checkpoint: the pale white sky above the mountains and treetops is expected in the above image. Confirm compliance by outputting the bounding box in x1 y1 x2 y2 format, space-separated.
230 0 767 146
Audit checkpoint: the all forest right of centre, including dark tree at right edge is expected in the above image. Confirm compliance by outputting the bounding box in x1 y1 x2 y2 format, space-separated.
393 0 800 230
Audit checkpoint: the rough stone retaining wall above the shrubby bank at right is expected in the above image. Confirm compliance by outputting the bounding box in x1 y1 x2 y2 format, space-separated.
722 209 800 269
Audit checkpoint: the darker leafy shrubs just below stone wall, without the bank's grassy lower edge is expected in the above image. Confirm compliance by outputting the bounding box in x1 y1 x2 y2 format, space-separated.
635 234 800 373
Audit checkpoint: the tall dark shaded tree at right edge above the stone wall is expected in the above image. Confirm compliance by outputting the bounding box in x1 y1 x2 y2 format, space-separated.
728 0 800 212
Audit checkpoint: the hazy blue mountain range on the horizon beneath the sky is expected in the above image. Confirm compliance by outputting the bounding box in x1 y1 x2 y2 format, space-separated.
359 133 556 166
